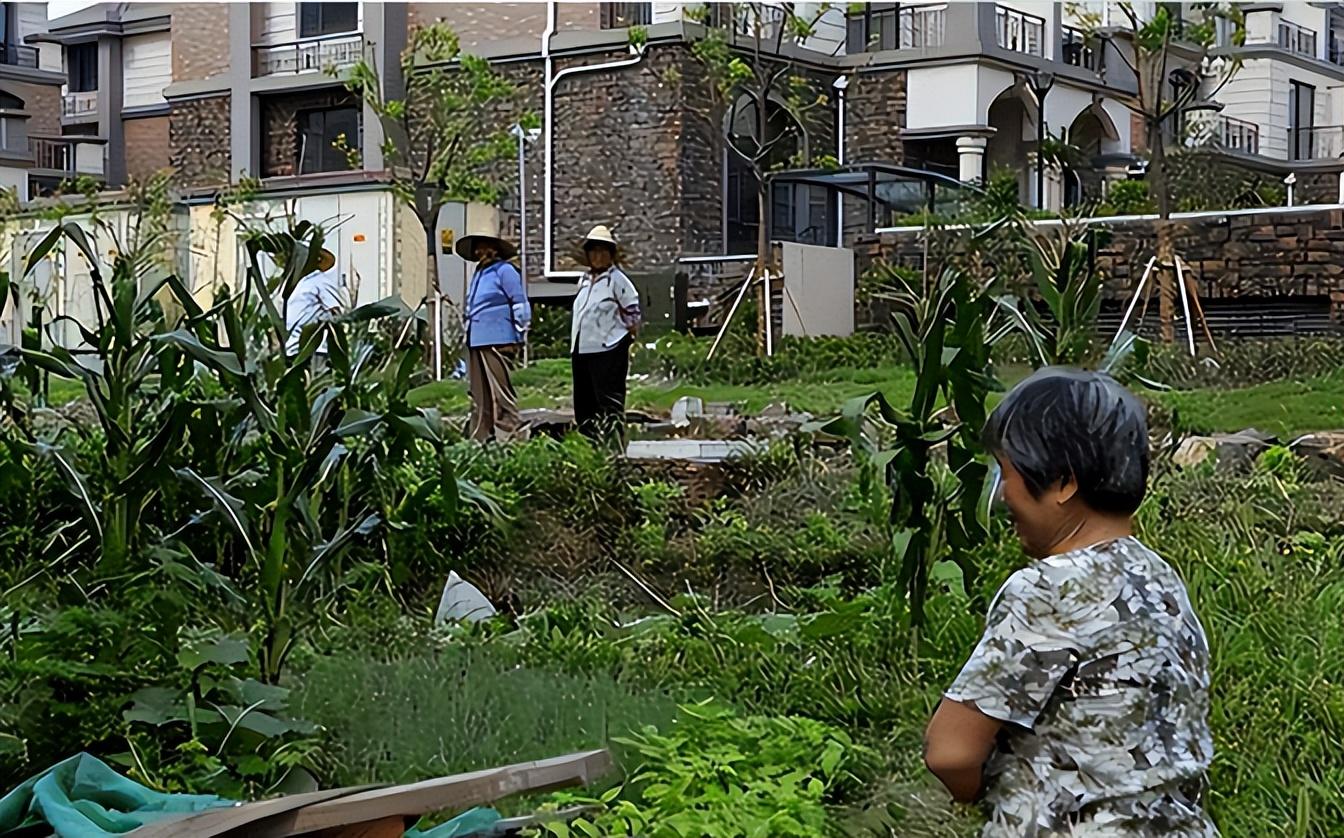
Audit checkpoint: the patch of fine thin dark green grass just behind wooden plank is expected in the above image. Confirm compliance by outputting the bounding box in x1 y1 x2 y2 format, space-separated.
294 646 676 786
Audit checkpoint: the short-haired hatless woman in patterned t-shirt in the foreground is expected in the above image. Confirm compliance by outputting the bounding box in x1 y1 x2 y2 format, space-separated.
925 369 1218 838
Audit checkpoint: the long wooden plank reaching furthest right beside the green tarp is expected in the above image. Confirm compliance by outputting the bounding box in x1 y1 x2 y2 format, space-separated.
240 749 612 838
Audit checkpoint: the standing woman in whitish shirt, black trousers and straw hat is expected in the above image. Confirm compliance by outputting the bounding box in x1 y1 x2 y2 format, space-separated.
570 224 640 438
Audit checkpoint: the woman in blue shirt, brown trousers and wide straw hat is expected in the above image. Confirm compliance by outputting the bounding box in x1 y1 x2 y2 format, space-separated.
454 222 532 442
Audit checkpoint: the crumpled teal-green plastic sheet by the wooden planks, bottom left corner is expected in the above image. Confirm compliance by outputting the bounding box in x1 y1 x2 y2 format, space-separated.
0 753 500 838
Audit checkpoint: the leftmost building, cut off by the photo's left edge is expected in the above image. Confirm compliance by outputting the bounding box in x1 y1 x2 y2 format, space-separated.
0 3 69 200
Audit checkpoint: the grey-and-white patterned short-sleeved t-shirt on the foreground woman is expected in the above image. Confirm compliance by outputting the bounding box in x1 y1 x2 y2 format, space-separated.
946 539 1218 838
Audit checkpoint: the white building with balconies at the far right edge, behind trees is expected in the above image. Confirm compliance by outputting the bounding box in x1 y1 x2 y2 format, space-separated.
1208 3 1344 201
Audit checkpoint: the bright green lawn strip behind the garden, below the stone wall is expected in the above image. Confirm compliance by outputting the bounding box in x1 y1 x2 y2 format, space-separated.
411 359 1344 440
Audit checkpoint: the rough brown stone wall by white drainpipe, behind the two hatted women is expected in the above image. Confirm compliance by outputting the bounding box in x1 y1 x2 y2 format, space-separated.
481 44 723 278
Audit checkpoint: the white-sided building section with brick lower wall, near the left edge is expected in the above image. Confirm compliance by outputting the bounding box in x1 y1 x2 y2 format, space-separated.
28 3 172 188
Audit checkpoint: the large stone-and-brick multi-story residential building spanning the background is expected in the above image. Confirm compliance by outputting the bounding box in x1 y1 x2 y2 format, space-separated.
23 0 1155 277
